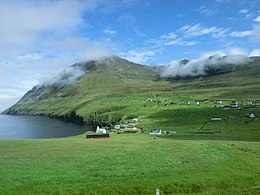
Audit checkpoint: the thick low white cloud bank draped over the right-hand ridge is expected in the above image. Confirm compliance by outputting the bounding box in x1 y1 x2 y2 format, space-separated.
161 52 258 78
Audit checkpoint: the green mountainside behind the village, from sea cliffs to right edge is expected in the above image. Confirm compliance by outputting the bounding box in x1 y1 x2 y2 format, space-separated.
3 57 260 140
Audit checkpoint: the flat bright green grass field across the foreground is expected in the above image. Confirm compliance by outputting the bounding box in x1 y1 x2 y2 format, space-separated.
0 134 260 194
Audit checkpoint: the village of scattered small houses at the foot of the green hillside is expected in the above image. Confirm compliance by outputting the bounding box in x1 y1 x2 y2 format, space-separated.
86 97 260 139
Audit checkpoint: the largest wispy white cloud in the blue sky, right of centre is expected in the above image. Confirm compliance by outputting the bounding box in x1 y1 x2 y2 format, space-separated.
180 24 228 38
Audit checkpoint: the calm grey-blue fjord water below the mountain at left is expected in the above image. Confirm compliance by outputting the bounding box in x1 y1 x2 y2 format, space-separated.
0 115 86 139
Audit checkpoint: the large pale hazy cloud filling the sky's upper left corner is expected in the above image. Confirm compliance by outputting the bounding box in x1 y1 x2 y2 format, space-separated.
0 0 87 55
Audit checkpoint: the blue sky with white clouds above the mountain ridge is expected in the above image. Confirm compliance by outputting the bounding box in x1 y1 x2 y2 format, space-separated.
0 0 260 111
